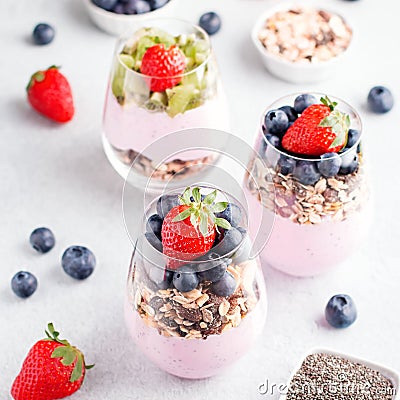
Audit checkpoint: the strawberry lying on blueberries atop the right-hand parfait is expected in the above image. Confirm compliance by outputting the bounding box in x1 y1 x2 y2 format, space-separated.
282 97 350 156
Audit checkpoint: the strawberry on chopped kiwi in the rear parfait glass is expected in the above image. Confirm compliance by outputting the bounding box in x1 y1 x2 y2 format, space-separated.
140 44 186 92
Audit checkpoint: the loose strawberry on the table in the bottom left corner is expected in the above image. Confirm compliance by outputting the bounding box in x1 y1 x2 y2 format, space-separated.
11 323 93 400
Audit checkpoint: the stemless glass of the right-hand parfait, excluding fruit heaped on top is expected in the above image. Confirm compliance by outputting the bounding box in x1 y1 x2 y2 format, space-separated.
244 93 371 276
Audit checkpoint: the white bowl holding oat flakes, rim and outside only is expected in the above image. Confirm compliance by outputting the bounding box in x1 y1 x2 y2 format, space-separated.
251 2 354 83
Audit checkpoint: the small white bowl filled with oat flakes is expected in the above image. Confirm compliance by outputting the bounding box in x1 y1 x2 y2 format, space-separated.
252 5 353 83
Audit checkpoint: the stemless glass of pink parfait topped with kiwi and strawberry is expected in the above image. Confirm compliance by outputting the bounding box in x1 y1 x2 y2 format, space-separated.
103 18 230 188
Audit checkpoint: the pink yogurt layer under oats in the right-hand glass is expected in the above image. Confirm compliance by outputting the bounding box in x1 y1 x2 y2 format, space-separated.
244 185 372 277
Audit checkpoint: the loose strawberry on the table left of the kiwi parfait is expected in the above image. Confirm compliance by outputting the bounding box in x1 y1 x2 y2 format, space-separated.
26 65 75 123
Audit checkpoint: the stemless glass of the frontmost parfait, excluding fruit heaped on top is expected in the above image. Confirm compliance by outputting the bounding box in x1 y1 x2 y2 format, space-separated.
125 186 267 379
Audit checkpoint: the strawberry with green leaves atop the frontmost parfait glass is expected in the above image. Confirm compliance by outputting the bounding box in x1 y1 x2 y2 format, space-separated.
161 188 231 269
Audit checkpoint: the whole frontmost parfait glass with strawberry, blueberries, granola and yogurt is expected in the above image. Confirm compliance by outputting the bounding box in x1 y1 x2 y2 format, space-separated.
125 186 267 379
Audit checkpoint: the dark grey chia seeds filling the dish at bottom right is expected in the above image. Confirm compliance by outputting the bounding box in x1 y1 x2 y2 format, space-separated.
286 353 395 400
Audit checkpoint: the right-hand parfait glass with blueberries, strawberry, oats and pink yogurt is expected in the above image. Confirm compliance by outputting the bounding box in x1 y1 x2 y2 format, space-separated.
244 93 371 276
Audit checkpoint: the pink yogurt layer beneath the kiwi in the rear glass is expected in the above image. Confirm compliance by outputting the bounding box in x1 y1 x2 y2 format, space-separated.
103 90 230 162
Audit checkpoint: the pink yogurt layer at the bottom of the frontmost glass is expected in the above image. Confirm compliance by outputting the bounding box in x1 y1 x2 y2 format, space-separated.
125 287 267 379
